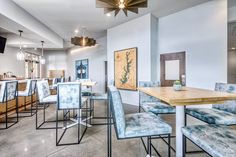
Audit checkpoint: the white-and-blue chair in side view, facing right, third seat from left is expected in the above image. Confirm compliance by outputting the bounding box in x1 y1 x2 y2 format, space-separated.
36 81 57 129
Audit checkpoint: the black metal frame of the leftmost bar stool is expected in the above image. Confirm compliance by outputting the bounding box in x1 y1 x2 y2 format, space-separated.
0 82 19 130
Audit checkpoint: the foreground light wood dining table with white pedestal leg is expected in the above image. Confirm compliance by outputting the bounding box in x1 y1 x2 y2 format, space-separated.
138 87 236 157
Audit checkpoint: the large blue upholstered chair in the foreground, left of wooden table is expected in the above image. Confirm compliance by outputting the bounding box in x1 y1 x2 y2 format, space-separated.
108 86 172 156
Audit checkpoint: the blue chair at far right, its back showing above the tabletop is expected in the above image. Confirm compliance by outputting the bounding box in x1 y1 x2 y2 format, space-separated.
186 83 236 125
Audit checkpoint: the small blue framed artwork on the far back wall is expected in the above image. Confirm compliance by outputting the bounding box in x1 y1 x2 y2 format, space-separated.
75 59 89 79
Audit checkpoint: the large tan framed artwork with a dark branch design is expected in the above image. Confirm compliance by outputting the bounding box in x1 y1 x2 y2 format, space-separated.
114 48 137 90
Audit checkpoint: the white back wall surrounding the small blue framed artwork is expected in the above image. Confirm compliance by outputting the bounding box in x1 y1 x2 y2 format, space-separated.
66 37 107 92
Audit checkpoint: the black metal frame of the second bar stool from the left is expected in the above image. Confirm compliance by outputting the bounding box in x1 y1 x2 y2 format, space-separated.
18 80 37 118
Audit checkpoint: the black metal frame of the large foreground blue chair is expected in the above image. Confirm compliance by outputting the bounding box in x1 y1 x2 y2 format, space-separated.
107 90 171 157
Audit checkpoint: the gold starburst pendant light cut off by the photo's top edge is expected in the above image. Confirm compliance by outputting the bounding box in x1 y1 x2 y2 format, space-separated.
96 0 148 16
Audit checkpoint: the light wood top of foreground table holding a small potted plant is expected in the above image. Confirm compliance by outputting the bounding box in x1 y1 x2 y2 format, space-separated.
138 87 236 106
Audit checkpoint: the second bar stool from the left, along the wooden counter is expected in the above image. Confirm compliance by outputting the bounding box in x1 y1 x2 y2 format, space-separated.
18 80 37 117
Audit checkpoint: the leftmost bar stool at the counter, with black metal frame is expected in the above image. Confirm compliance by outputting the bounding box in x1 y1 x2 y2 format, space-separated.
0 81 18 130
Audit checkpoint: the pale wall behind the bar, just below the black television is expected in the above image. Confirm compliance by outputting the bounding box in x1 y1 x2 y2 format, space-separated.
0 46 25 77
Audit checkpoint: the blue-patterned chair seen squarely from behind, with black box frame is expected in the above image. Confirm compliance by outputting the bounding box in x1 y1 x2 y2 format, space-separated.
56 82 88 146
